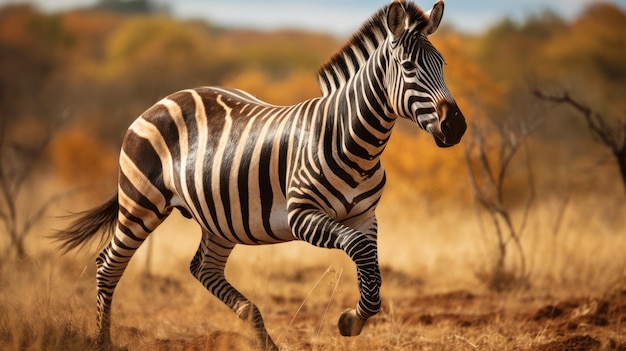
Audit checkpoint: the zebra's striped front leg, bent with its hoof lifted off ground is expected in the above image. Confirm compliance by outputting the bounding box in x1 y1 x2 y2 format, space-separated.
290 211 381 336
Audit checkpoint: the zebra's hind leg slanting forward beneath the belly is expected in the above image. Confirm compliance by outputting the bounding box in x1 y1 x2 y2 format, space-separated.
190 232 278 351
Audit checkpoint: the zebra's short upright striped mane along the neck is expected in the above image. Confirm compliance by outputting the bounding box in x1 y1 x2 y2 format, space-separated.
317 0 429 96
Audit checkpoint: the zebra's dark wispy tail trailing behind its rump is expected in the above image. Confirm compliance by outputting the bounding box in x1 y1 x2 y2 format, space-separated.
53 191 119 253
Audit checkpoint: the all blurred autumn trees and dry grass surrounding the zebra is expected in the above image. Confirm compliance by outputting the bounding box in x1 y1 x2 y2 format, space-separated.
0 2 626 350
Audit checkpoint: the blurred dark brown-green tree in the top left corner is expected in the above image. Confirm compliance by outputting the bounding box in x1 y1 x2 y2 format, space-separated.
0 5 73 122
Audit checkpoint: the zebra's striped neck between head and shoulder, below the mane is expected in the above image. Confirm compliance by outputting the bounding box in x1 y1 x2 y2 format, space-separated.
328 46 396 182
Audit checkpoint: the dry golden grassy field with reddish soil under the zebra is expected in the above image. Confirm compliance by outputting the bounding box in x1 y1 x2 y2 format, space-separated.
0 187 626 350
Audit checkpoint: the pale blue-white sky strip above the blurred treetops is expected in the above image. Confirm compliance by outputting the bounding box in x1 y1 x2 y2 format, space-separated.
0 0 626 36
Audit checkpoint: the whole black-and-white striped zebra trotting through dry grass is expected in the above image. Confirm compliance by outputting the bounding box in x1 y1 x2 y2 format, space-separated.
56 0 467 350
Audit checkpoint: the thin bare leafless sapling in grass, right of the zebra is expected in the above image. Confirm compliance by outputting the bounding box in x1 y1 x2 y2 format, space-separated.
465 113 543 291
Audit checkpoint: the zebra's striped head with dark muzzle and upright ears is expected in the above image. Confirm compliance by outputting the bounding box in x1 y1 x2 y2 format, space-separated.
386 0 467 147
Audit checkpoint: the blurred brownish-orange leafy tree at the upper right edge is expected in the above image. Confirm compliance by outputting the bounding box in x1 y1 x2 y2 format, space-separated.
530 3 626 195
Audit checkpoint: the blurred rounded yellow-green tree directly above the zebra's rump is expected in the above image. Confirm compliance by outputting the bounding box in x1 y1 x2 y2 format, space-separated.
70 16 229 146
